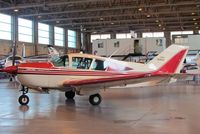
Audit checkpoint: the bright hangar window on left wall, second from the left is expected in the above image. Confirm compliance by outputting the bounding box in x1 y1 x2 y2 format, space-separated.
18 18 33 43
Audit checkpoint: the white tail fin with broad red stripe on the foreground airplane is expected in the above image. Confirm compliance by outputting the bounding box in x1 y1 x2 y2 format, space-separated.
147 44 189 73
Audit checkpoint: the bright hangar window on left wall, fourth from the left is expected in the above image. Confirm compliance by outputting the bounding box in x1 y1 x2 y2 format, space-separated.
54 27 64 46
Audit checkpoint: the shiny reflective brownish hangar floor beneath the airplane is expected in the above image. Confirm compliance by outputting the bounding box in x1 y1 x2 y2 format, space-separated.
0 79 200 134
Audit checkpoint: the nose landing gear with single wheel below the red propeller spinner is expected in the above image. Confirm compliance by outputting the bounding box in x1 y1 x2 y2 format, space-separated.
18 85 29 105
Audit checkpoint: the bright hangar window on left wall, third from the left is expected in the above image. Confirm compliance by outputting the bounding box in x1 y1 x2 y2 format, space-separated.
38 23 50 44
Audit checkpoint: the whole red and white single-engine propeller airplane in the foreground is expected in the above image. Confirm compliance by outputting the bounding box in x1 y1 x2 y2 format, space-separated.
1 45 188 105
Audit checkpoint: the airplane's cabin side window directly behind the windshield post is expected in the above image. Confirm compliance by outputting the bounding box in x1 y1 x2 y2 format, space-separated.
72 57 92 69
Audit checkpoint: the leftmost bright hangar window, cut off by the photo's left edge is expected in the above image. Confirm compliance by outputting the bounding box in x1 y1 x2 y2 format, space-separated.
0 14 12 40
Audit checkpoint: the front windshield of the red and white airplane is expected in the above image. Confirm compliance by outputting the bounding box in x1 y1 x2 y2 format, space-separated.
52 55 69 67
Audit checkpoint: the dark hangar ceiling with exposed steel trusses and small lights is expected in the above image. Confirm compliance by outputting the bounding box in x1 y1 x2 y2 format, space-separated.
0 0 200 33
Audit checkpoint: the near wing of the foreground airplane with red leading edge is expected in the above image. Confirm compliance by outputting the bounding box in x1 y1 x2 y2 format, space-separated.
63 73 172 90
